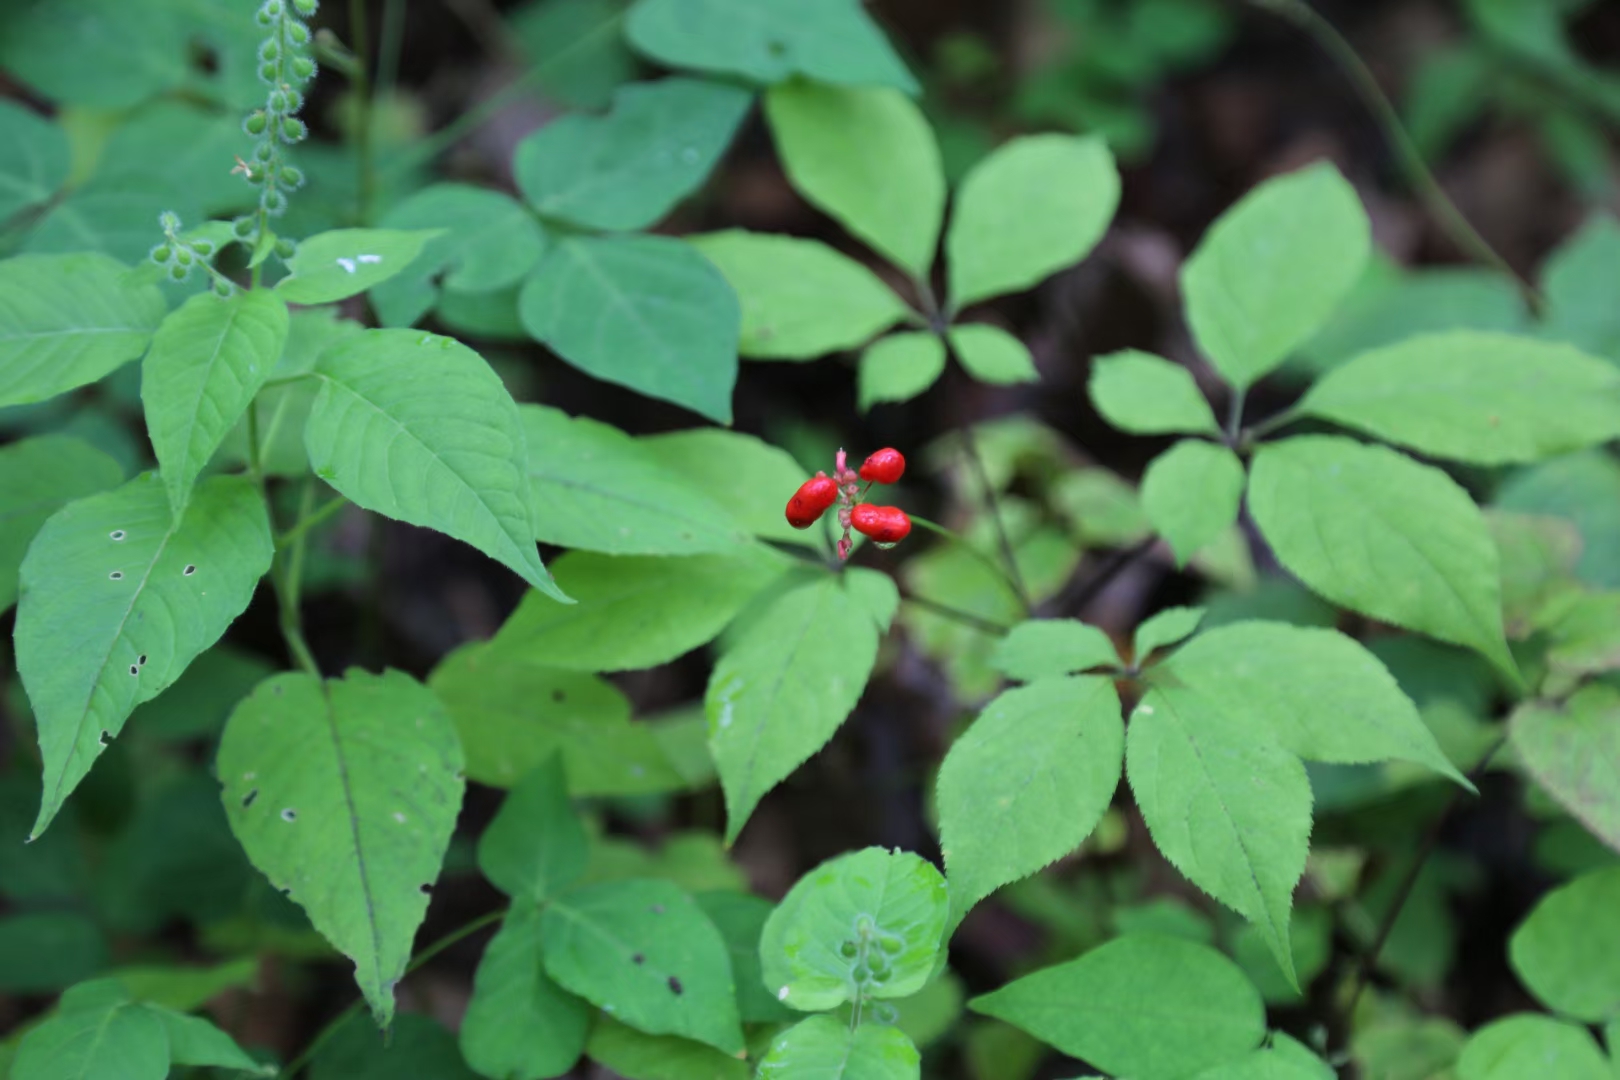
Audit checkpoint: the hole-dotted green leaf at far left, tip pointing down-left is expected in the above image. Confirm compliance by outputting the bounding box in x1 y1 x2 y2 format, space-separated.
16 473 274 837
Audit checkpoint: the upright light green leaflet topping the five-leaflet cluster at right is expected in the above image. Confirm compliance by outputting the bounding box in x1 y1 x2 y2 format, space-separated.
1181 164 1372 390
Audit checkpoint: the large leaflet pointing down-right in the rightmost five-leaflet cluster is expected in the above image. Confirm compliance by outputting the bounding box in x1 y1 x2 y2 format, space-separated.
1249 436 1516 678
